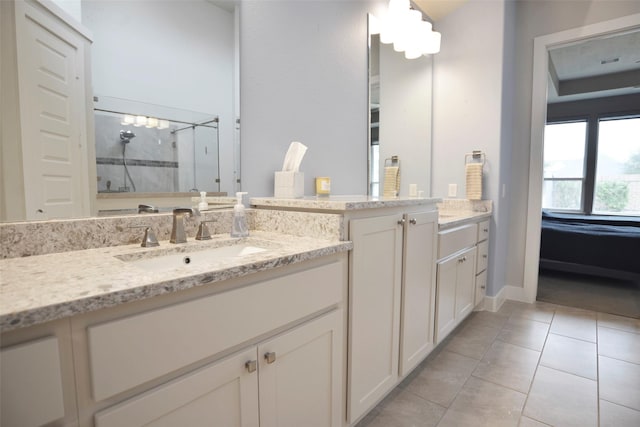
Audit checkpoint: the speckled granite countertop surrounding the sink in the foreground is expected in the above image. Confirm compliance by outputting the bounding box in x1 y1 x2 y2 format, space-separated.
0 231 353 332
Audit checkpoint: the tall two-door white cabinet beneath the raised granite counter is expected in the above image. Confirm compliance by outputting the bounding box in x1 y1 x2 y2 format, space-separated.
348 210 438 423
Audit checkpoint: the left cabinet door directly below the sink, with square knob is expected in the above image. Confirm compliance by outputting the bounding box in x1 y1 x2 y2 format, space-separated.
95 347 259 427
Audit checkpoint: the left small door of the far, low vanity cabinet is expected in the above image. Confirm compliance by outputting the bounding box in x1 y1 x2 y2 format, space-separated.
436 257 460 343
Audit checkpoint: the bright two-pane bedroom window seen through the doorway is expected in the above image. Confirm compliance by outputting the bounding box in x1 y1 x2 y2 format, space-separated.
542 116 640 216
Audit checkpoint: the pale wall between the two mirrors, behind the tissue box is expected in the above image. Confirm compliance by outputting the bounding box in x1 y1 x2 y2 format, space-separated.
240 0 388 196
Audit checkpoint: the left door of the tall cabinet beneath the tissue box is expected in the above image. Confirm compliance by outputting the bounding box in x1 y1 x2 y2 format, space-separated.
348 215 402 422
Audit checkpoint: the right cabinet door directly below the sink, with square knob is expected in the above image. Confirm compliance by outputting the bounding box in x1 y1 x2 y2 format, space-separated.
258 309 343 427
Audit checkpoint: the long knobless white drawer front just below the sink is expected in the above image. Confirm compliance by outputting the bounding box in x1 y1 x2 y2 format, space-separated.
87 261 346 401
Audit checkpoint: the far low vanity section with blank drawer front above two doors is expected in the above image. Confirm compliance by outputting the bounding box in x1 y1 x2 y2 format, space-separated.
436 223 478 343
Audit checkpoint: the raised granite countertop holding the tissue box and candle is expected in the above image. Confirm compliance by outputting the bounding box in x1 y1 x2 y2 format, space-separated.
250 195 441 212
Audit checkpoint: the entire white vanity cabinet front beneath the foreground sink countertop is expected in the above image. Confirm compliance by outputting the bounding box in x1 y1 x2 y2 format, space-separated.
0 252 348 427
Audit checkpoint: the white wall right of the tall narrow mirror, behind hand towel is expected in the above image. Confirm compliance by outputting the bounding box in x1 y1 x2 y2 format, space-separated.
432 0 508 296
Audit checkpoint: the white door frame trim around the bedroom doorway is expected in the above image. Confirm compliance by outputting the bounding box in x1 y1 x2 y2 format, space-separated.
505 0 640 288
